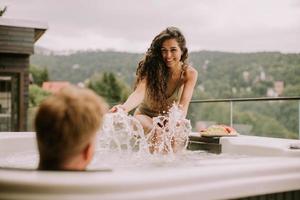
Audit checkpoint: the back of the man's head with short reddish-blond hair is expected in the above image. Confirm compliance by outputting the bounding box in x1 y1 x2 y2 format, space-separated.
34 86 107 170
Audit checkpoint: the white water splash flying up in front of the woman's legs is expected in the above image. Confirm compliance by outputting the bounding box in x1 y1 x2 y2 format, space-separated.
100 104 192 155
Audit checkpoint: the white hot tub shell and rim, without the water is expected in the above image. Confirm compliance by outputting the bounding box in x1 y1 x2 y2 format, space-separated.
0 132 300 200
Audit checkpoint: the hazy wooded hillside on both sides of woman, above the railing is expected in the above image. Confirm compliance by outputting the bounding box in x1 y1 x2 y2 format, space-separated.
31 51 300 98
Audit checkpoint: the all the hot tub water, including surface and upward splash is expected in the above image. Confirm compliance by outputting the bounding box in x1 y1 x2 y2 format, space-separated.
0 104 248 170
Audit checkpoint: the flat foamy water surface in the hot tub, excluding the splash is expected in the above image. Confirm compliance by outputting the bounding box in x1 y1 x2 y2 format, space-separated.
0 148 252 171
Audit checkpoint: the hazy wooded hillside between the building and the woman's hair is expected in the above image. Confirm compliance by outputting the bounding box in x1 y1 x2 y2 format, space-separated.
31 51 142 86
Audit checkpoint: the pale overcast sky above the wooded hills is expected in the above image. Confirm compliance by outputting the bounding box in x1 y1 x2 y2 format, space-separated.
0 0 300 53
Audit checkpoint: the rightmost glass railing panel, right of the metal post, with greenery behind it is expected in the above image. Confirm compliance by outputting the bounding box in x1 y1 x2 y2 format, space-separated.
233 100 299 139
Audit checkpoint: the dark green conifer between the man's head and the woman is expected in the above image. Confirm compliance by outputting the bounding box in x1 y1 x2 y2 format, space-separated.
87 72 129 105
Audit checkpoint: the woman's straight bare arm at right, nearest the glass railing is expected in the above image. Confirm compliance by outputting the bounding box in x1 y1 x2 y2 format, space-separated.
179 66 198 117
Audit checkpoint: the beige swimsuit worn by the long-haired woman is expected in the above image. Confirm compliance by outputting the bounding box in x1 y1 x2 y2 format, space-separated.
137 68 185 118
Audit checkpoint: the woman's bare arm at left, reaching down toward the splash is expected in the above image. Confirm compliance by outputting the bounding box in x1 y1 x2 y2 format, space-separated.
120 79 146 112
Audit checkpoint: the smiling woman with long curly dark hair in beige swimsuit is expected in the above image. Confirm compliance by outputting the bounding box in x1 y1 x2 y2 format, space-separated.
111 27 198 134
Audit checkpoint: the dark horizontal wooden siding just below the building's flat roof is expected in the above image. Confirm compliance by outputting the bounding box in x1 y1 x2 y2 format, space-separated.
0 26 35 54
